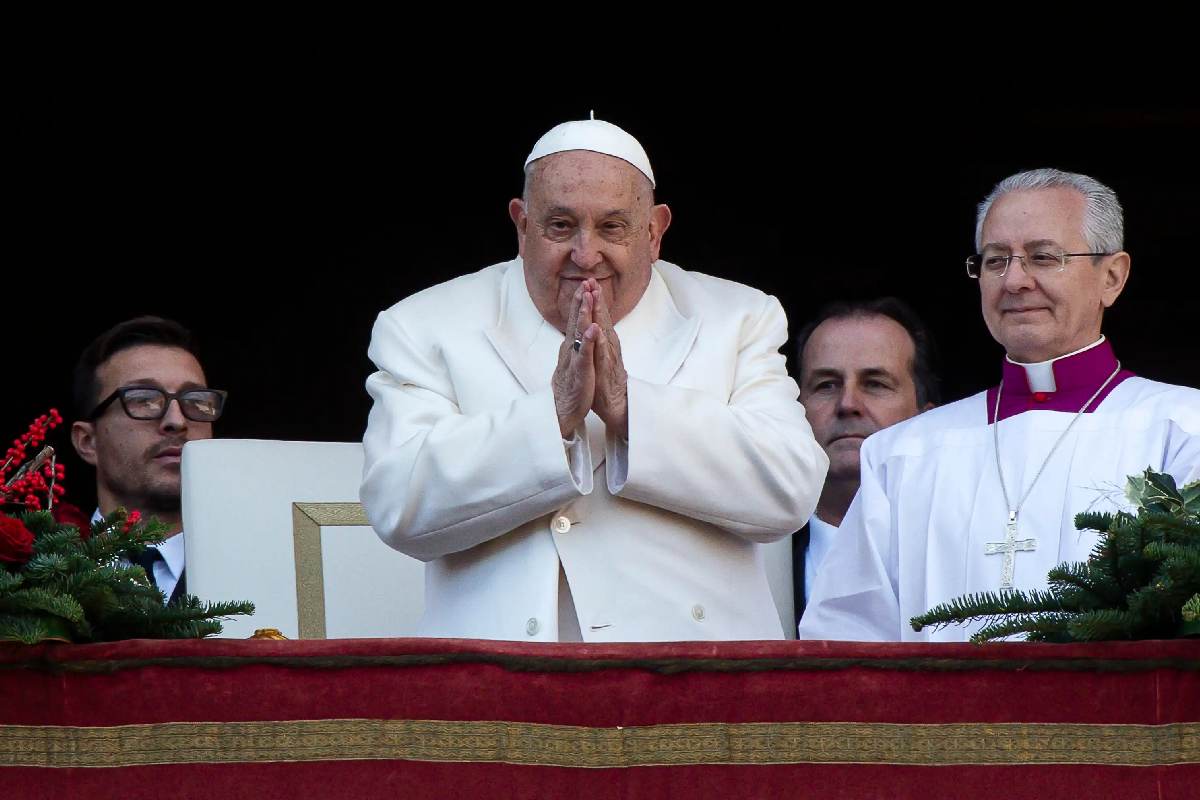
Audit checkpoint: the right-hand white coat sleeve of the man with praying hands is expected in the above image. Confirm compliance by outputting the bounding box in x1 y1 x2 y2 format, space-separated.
605 296 829 542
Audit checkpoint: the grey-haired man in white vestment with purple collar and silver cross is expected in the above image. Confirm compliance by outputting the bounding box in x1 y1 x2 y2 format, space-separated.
799 169 1200 642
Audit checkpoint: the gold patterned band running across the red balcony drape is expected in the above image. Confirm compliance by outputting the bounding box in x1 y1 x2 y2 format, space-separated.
0 720 1200 769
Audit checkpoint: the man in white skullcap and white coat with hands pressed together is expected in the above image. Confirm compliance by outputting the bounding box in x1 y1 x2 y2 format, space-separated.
361 120 828 642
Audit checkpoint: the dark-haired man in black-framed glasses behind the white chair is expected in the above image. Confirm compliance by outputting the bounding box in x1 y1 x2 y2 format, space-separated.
71 317 226 600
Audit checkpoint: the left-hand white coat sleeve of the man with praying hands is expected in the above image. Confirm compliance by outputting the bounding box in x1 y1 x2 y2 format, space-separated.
360 312 593 561
